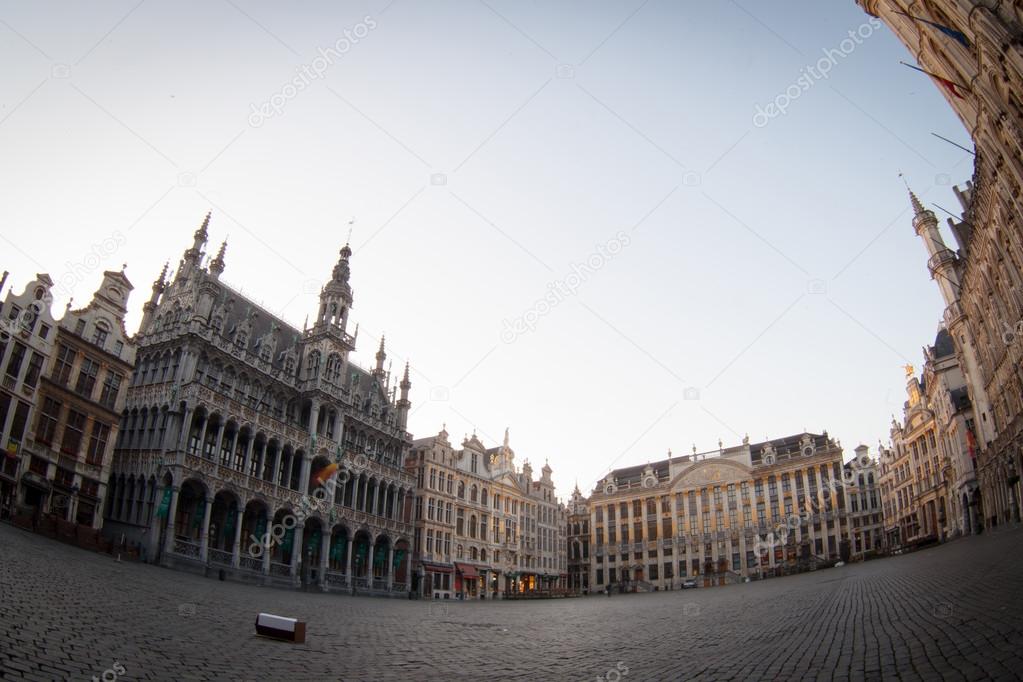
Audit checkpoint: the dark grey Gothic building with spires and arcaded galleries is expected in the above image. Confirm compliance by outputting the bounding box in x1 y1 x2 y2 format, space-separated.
106 216 415 594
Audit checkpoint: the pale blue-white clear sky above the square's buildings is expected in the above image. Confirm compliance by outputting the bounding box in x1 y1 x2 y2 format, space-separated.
0 0 973 497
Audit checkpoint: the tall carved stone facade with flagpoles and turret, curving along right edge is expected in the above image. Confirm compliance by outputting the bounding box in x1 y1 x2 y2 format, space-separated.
857 0 1023 526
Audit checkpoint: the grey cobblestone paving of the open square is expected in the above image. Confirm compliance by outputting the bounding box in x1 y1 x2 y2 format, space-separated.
0 525 1023 682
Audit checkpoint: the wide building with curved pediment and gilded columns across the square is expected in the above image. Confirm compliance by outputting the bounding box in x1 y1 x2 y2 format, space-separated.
588 433 849 590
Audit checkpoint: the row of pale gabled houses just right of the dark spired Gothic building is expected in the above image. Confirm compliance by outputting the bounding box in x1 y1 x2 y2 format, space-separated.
406 428 568 599
